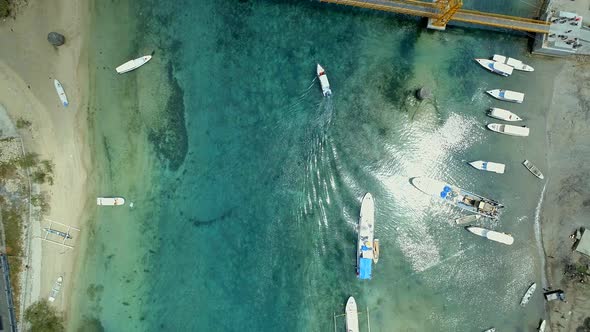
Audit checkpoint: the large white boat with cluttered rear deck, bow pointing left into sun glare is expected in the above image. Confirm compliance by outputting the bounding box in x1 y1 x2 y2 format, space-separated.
410 177 504 219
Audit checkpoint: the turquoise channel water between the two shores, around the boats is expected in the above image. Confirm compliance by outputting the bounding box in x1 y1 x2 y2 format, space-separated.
70 1 557 331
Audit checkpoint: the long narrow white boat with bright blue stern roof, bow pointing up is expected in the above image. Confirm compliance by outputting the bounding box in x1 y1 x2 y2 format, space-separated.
356 193 375 279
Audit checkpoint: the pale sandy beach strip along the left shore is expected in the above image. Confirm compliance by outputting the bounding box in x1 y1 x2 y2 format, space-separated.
0 0 89 323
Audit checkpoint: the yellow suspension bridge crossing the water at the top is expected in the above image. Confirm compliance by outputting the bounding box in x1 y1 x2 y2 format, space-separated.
320 0 549 33
